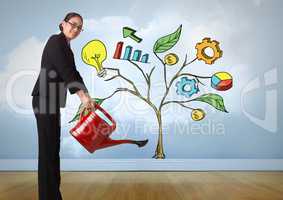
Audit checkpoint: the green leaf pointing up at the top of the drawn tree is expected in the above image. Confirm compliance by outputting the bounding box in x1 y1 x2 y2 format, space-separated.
153 25 182 53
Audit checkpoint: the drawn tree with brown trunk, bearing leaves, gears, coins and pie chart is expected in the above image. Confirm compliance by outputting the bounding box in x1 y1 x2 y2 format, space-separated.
70 25 232 159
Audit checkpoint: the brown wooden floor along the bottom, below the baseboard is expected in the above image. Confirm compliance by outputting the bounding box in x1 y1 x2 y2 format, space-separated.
0 172 283 200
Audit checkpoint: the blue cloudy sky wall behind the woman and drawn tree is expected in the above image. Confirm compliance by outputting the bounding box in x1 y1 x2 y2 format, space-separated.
0 0 283 158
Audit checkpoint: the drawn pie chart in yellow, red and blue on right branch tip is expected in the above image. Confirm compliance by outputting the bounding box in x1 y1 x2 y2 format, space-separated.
211 72 233 91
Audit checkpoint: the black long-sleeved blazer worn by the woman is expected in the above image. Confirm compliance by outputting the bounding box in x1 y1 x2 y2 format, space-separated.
31 32 88 107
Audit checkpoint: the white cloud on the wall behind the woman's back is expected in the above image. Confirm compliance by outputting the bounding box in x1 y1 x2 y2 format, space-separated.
0 37 44 113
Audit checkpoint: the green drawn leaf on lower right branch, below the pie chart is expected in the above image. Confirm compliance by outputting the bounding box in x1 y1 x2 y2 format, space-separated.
192 93 228 112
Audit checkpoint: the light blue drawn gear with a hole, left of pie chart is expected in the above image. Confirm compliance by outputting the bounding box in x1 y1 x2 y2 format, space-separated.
176 77 199 98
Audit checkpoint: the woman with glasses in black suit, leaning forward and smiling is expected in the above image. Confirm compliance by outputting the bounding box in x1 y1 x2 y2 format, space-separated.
32 13 95 200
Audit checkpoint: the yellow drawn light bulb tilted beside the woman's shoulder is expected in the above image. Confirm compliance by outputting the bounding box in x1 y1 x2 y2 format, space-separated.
81 40 107 77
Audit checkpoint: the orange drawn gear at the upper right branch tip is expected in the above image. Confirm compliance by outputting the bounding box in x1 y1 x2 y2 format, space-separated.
195 38 223 65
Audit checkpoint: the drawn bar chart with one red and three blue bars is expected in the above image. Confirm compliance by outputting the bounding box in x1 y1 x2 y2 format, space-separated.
113 42 149 63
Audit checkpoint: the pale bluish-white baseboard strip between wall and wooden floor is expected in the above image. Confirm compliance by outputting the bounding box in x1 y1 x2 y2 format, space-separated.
0 159 283 171
